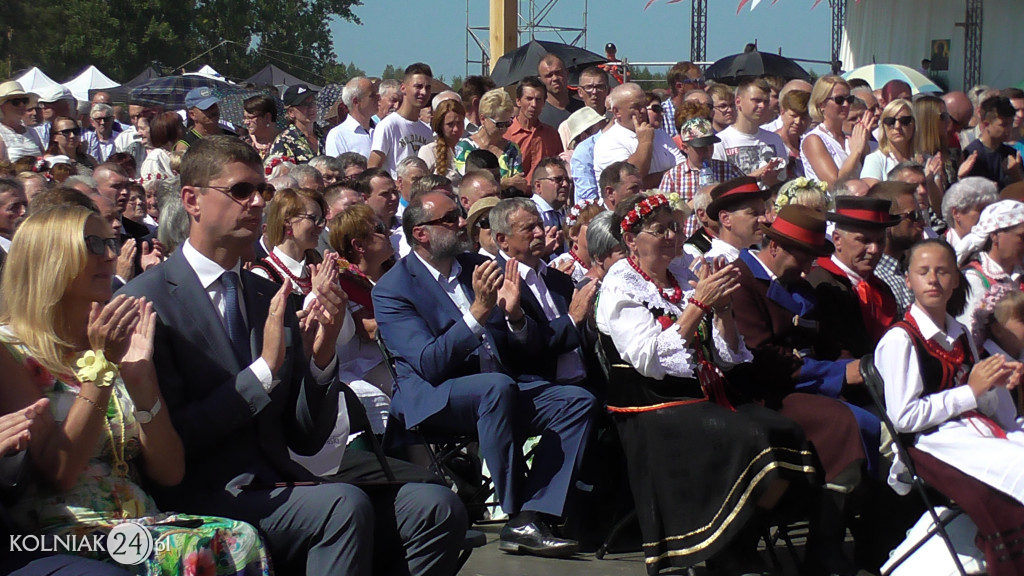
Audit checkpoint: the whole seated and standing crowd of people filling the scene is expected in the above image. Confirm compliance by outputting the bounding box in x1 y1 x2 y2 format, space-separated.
0 55 1024 576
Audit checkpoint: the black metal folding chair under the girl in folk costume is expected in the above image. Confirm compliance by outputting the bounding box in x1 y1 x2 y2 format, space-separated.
860 354 967 576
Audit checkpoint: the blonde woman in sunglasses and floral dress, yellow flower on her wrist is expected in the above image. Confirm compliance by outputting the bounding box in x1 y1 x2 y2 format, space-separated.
0 205 269 574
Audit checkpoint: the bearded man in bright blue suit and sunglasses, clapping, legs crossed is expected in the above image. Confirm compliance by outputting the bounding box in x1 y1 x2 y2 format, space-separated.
373 192 595 558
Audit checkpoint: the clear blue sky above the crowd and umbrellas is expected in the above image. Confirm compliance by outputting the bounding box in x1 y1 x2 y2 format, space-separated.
331 0 830 80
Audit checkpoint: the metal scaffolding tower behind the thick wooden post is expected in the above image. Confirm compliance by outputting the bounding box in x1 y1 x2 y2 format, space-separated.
466 0 589 76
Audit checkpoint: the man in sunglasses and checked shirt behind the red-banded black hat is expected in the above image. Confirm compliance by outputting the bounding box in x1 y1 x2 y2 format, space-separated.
867 180 925 318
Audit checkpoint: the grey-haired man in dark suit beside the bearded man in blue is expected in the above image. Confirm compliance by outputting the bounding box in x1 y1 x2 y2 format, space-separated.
489 194 597 383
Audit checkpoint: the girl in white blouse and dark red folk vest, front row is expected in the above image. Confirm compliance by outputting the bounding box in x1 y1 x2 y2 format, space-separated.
874 240 1024 576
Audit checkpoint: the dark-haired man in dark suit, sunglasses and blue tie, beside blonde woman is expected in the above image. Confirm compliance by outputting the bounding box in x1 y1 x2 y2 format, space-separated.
123 136 466 576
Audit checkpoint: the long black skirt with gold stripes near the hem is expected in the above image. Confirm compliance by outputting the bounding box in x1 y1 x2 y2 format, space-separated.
612 402 819 574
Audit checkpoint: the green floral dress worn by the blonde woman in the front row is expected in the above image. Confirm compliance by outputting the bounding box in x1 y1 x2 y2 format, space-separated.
0 329 273 576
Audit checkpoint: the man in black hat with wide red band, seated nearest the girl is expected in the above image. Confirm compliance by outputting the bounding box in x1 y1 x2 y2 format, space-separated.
807 196 900 360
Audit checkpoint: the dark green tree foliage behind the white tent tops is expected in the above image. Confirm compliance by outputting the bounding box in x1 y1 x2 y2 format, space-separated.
0 0 361 82
